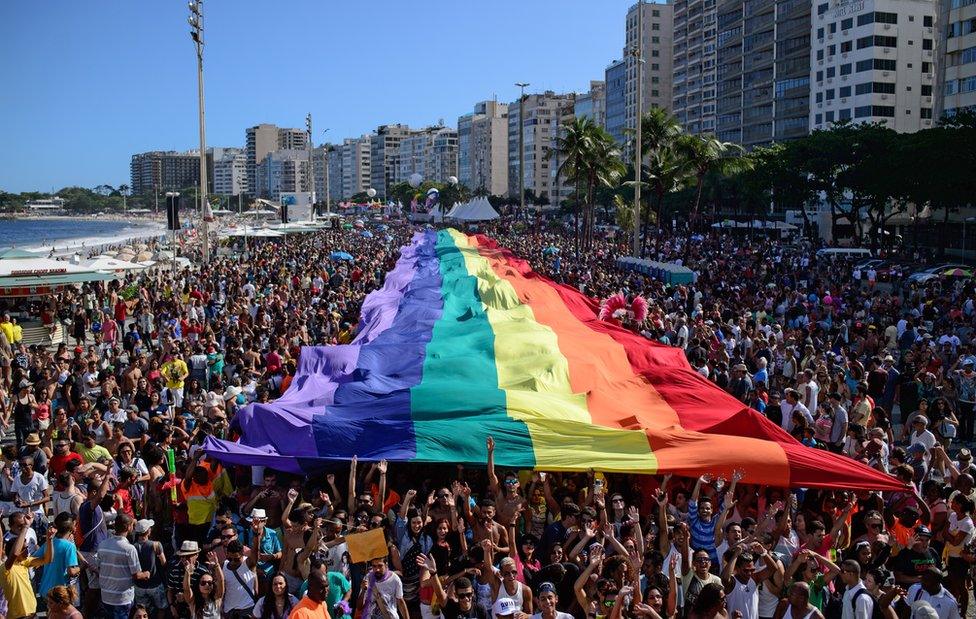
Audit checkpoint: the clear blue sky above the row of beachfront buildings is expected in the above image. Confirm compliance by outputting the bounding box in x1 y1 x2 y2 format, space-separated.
0 0 632 192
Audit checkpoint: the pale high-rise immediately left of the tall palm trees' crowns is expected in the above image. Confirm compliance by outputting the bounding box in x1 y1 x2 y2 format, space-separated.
508 91 576 199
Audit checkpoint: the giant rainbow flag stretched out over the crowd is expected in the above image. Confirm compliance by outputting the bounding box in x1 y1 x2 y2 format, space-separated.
206 230 902 489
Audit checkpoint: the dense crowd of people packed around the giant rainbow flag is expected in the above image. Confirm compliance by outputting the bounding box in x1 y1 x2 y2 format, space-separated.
0 219 976 619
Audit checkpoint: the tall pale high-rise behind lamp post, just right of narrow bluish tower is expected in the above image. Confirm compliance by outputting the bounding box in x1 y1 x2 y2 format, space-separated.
624 2 674 134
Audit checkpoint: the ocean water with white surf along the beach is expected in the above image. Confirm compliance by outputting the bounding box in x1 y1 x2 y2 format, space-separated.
0 218 166 251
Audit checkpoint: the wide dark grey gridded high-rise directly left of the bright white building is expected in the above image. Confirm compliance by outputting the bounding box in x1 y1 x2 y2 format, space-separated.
715 0 810 148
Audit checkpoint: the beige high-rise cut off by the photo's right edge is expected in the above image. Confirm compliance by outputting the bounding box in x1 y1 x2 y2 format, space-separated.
935 0 976 119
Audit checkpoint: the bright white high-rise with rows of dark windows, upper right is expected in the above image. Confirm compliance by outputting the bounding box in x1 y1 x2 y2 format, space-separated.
810 0 936 132
